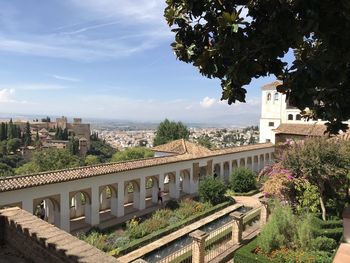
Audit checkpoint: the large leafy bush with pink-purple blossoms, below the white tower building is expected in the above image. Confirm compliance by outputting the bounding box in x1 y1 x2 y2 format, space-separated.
261 139 350 220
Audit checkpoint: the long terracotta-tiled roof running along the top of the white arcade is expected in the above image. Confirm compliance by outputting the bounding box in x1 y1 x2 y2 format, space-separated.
0 142 273 192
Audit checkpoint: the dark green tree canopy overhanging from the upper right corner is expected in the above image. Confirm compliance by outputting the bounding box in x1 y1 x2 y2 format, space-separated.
165 0 350 133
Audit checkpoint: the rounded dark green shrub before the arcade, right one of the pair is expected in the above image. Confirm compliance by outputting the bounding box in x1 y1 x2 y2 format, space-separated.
230 168 257 193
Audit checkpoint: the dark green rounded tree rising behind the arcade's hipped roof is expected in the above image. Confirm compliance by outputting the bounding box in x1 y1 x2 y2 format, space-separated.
153 119 190 146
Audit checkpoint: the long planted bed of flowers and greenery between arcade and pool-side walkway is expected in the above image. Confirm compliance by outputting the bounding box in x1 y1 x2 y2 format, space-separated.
80 199 233 256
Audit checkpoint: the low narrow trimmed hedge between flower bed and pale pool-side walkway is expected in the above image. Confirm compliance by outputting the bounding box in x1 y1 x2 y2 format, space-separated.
108 199 234 256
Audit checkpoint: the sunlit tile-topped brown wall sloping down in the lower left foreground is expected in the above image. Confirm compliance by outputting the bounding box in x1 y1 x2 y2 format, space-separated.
0 207 119 263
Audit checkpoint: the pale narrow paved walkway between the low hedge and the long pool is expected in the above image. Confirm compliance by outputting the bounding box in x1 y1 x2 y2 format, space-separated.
118 204 242 263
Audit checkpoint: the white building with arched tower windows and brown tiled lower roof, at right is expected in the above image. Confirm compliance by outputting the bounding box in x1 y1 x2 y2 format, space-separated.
259 81 342 143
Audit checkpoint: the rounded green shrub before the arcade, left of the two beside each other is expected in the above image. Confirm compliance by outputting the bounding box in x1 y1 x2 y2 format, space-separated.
199 176 227 205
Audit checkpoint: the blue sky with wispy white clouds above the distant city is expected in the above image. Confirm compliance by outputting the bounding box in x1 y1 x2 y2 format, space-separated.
0 0 274 126
